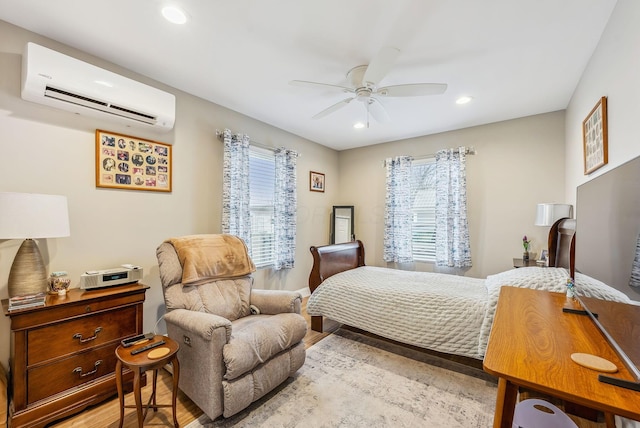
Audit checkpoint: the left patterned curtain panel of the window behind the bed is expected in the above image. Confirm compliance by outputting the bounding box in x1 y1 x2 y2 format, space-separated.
383 156 413 263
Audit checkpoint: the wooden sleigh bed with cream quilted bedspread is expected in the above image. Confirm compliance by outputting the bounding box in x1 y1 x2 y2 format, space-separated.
307 219 630 360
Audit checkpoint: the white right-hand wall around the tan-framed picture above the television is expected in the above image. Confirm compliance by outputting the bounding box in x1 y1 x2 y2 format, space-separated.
566 0 640 203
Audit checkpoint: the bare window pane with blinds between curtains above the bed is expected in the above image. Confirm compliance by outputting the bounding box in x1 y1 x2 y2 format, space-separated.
411 159 436 262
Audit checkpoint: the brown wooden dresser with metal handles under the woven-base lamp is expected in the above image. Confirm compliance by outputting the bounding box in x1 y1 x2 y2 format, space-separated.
2 284 149 427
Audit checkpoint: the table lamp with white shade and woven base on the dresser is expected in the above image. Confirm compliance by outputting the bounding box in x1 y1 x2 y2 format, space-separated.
0 192 70 297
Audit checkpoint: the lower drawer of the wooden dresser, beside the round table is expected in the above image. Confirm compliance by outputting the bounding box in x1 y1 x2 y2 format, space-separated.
27 343 118 404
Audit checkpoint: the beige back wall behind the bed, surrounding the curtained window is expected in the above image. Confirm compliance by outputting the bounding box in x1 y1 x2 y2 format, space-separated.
339 112 565 278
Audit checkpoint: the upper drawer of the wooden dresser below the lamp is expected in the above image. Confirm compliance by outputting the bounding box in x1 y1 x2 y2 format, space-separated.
27 306 137 366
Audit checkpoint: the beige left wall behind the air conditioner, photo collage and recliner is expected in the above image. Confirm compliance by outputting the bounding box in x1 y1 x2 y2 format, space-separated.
0 21 338 367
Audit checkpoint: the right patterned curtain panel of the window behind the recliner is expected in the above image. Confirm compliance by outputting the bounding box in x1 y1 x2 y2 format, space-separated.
274 148 298 270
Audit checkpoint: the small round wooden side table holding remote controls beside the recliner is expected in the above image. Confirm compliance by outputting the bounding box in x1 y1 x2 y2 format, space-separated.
116 336 180 428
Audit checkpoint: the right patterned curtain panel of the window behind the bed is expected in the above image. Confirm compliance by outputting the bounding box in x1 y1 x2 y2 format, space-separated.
436 147 471 268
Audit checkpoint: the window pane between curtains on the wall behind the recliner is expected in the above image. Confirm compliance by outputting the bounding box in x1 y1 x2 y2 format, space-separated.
249 146 276 267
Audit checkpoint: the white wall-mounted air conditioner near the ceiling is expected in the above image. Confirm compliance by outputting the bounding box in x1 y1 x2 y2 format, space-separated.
22 43 176 132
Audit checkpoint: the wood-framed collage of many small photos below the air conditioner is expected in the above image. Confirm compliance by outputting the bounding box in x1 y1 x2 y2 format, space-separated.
96 129 172 192
